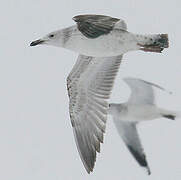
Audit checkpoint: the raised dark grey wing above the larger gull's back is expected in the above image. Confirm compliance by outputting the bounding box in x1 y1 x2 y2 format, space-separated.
73 15 127 38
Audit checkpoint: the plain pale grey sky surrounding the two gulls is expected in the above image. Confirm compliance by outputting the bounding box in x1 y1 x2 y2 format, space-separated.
0 0 181 180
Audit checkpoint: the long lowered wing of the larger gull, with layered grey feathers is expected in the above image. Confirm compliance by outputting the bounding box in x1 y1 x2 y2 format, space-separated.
67 55 122 173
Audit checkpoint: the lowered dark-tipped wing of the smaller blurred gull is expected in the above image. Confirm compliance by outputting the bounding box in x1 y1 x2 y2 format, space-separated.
113 117 151 174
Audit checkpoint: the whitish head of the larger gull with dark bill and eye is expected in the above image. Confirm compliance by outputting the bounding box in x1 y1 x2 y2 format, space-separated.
30 30 65 47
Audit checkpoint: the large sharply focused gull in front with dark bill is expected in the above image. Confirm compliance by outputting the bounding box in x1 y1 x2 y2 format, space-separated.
30 15 168 173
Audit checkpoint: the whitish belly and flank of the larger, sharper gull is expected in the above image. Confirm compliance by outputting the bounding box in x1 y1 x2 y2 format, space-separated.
65 30 139 57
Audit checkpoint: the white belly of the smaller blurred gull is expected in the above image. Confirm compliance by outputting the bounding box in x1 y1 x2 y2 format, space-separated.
122 105 161 121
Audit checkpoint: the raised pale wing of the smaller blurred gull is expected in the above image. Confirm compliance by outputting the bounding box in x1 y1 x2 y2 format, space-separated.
123 78 166 104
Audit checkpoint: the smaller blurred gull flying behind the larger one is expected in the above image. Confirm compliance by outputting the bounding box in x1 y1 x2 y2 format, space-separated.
108 78 179 174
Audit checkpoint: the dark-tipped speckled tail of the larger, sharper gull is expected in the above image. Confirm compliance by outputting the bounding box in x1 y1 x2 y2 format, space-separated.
138 34 169 53
